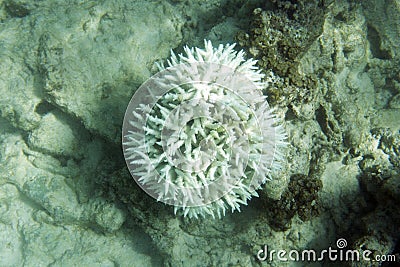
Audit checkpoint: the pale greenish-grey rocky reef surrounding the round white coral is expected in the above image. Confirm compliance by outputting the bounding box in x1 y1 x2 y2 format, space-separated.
0 0 400 266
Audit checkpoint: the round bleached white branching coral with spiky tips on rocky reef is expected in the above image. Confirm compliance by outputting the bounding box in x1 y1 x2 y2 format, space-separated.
123 41 286 218
